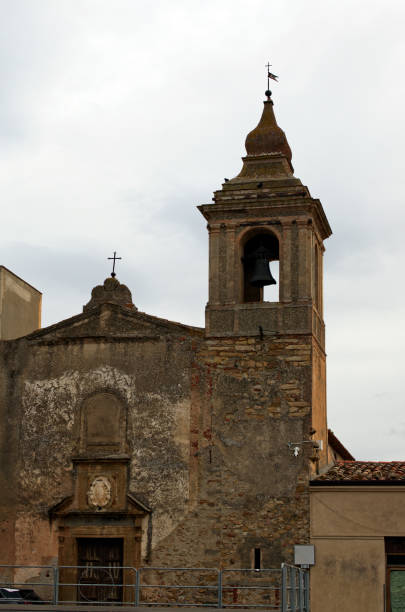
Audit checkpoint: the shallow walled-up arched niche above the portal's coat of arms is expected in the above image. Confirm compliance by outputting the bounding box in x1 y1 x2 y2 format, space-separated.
80 392 126 455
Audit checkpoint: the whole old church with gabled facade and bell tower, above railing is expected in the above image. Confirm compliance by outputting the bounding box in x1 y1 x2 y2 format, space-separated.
0 91 401 610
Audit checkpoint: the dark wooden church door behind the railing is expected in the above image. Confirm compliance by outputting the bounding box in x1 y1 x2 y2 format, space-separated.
77 538 123 602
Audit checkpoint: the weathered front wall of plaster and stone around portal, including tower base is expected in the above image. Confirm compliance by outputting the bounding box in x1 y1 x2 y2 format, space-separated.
0 318 312 580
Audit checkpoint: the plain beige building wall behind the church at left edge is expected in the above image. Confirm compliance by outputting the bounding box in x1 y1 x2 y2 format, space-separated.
0 266 42 340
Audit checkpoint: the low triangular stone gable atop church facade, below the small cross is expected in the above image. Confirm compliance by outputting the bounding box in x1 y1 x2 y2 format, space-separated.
26 304 203 342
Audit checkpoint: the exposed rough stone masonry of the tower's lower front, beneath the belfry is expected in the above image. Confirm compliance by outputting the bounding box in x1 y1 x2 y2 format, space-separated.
148 336 312 568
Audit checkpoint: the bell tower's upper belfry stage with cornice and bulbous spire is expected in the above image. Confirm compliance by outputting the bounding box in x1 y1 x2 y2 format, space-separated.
199 91 332 344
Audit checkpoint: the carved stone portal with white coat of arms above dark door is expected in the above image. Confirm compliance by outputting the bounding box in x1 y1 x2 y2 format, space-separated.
50 457 151 603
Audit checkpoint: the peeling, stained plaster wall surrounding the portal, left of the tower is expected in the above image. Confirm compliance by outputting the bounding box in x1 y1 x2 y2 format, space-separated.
1 328 202 563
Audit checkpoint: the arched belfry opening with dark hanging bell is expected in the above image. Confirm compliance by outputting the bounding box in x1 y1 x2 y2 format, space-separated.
242 231 279 302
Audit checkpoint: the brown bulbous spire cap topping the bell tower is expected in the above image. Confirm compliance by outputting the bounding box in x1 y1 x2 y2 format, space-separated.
245 91 292 162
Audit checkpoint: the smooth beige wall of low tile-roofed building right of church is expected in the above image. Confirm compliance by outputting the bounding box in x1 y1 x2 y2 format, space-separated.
310 485 405 612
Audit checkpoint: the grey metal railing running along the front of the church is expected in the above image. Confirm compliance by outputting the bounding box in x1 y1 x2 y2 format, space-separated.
0 563 310 612
